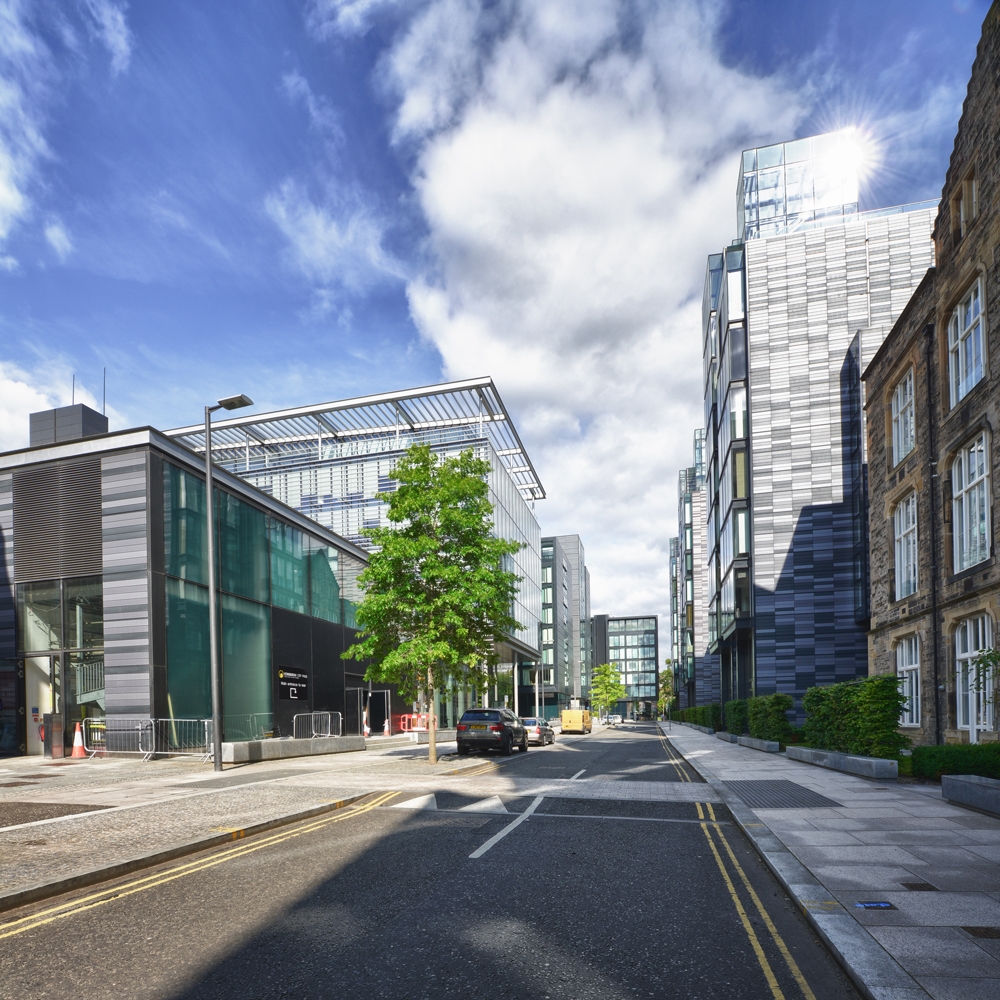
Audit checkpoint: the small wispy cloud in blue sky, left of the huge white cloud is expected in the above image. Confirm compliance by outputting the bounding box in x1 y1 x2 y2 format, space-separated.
265 180 402 298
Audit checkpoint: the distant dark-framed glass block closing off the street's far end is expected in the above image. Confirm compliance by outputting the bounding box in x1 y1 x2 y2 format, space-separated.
594 615 659 718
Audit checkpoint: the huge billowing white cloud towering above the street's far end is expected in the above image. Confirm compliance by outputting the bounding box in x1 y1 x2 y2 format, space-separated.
384 0 803 615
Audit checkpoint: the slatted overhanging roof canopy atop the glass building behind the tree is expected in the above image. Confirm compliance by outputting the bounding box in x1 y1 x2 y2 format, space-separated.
164 378 545 501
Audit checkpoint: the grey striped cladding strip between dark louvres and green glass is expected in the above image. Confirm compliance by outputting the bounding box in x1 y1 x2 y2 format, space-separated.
101 451 152 716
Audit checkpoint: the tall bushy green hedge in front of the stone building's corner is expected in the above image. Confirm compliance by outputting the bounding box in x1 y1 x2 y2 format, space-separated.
802 674 910 758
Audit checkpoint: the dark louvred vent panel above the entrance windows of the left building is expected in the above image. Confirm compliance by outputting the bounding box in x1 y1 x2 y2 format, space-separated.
13 456 101 582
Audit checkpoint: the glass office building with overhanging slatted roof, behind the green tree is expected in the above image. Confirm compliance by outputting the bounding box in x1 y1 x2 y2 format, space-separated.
166 378 545 676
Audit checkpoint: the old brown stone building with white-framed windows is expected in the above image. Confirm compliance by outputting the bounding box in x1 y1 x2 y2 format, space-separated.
864 3 1000 744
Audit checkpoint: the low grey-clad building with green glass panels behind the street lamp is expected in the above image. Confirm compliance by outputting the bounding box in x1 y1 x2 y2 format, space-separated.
0 402 378 753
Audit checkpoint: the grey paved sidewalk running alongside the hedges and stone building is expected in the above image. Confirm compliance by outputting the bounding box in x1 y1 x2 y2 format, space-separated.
661 723 1000 1000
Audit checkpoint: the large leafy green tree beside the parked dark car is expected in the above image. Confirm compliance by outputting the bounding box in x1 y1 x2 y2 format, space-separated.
342 445 521 764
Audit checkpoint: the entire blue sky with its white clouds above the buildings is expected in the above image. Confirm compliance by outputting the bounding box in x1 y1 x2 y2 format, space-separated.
0 0 988 613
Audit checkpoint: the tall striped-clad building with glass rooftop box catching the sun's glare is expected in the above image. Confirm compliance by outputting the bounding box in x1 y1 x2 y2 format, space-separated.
702 129 937 714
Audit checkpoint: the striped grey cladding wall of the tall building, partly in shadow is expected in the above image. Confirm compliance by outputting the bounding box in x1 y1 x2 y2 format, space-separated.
747 209 935 712
